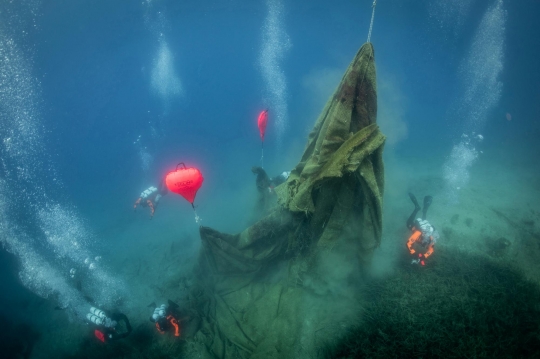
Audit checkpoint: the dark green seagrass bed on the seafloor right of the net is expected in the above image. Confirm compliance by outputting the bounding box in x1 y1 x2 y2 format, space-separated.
326 250 540 358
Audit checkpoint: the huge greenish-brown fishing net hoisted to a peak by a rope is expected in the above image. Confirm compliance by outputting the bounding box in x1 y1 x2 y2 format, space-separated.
188 43 385 358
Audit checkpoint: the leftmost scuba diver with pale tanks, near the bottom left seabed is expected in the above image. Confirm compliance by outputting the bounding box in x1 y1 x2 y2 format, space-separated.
86 307 131 343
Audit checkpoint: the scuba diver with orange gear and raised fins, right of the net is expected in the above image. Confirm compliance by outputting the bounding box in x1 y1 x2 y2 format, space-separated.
407 192 439 266
